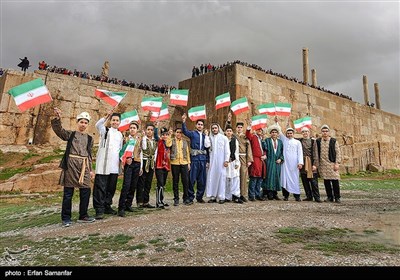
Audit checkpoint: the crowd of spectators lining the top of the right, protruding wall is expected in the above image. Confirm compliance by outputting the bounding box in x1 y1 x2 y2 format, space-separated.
192 60 353 100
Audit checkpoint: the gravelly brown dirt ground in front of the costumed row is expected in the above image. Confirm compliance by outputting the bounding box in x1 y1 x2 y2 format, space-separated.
3 150 400 267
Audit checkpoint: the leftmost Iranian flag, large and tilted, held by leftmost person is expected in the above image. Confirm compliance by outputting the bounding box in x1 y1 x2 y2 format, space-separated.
8 78 53 112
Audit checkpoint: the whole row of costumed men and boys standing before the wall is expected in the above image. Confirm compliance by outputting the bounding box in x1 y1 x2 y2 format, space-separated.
52 108 341 226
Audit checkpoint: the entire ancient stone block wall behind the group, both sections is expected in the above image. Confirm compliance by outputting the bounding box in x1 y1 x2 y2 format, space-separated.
0 64 400 173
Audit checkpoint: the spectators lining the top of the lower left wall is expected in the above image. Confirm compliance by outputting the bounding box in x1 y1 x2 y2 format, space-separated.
39 61 176 94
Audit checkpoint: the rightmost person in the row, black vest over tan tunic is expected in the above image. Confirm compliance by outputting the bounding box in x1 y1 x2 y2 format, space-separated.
316 124 342 203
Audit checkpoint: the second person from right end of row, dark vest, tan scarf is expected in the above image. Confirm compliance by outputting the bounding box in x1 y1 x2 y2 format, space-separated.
299 127 321 202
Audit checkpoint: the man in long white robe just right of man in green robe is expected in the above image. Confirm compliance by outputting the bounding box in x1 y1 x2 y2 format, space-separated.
277 123 304 201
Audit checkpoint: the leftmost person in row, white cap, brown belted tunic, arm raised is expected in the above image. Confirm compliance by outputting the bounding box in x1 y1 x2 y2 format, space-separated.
51 108 95 227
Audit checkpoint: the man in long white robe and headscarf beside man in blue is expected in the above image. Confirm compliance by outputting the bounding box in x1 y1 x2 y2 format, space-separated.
206 123 230 204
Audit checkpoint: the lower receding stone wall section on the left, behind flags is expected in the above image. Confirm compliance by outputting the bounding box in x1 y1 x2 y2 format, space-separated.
0 70 175 147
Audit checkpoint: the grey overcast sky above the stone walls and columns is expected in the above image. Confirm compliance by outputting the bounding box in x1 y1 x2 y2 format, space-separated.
0 0 400 115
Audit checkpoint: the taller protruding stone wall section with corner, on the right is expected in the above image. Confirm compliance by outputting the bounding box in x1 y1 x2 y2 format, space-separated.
176 64 400 173
